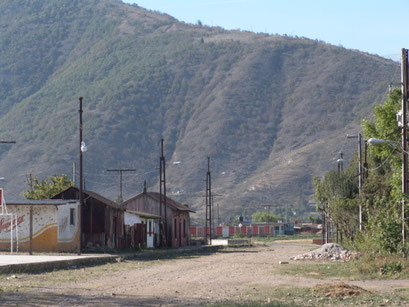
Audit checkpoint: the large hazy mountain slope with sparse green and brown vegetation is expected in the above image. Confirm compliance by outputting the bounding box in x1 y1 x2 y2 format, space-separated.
0 0 400 219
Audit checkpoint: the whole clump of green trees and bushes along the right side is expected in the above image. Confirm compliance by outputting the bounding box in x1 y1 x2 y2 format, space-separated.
314 89 404 252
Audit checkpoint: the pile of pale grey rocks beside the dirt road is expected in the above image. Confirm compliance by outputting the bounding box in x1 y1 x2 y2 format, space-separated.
291 243 357 261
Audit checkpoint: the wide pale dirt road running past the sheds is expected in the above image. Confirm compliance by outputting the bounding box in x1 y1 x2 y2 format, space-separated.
3 243 409 306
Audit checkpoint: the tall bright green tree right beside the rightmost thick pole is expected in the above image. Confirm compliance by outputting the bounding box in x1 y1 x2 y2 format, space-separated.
361 89 404 252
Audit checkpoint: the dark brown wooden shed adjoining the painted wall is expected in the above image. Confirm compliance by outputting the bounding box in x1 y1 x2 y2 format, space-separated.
53 187 126 249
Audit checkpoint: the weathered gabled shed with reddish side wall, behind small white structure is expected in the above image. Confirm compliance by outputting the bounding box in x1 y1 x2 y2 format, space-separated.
121 188 195 247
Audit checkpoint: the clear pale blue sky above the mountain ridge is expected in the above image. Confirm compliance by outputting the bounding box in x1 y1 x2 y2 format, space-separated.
124 0 409 59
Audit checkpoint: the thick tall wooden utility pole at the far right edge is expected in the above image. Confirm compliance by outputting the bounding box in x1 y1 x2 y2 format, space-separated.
401 49 408 245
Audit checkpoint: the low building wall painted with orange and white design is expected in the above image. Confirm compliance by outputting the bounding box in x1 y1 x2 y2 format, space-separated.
0 203 79 252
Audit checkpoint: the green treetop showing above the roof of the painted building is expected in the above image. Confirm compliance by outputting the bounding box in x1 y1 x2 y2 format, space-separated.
24 174 73 200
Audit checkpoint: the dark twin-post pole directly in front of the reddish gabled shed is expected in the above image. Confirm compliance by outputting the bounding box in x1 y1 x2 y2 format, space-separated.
159 139 167 247
